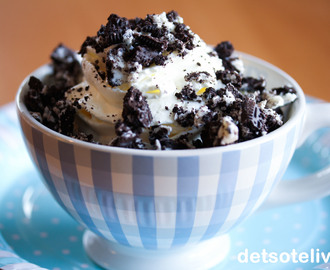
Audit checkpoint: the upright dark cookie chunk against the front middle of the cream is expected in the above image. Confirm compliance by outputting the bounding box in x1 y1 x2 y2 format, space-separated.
122 87 152 128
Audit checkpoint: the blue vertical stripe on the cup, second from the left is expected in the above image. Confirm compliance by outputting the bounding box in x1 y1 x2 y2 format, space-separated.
58 141 98 233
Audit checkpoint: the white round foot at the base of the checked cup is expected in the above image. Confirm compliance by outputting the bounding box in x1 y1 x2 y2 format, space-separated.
83 230 230 270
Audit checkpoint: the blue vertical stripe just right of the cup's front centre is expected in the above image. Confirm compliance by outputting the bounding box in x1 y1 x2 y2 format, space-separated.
172 156 199 246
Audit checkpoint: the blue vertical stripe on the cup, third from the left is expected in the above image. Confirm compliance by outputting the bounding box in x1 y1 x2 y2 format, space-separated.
91 150 129 246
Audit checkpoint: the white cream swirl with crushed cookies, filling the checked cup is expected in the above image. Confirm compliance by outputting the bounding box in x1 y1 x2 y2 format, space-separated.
25 11 296 149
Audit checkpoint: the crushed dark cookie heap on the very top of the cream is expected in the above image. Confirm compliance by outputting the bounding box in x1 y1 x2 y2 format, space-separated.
79 11 195 86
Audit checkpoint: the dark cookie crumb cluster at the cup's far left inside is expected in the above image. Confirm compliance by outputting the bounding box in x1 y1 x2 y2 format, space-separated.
24 44 82 139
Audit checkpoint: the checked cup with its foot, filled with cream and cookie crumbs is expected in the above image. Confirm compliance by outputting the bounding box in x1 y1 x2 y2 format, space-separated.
17 10 329 269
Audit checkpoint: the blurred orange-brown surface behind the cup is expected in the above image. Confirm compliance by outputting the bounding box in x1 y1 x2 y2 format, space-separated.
0 0 330 105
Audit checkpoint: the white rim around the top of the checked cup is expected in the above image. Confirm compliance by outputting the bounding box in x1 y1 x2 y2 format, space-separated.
15 51 306 157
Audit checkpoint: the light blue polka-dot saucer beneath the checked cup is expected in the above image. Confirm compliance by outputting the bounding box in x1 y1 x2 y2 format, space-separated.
0 104 330 270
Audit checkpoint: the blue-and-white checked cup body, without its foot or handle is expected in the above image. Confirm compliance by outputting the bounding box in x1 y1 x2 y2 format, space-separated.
17 54 305 250
